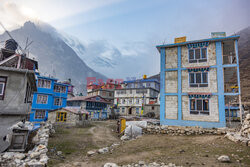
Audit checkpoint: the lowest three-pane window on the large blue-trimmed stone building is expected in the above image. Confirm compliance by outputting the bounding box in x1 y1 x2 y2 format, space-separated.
190 99 209 115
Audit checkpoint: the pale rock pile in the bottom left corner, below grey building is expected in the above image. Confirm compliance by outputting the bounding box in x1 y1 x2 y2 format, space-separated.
0 123 55 167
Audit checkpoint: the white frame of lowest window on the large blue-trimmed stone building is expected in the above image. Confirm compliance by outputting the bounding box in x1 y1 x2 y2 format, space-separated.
189 98 210 115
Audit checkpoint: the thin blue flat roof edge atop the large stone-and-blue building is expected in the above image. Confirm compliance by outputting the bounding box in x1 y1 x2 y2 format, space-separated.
156 35 240 52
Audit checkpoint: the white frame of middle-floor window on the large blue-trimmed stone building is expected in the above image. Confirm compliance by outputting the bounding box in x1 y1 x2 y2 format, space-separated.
188 71 209 88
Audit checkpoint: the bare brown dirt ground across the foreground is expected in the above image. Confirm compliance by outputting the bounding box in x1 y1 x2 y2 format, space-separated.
49 121 250 167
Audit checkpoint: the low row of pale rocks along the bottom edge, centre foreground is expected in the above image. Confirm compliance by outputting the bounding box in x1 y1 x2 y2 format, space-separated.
104 161 182 167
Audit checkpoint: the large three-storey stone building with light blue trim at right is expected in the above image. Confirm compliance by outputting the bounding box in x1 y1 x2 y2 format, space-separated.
156 36 241 128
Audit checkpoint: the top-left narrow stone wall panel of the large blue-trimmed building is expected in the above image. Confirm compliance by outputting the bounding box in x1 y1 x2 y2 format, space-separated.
165 47 177 69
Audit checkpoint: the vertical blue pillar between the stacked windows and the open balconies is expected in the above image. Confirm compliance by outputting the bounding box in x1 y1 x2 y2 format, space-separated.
215 42 226 127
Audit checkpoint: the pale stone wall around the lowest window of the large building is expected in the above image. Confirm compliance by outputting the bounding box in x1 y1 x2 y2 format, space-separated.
182 96 219 122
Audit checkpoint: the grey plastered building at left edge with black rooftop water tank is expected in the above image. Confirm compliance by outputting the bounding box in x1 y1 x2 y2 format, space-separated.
0 39 38 152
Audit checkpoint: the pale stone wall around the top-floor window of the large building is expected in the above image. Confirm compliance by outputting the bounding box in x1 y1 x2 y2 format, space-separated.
181 42 216 67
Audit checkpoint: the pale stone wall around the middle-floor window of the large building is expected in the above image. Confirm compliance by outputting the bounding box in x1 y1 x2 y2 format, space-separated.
181 68 217 93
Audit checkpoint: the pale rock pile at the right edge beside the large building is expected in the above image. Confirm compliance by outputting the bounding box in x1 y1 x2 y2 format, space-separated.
225 114 250 146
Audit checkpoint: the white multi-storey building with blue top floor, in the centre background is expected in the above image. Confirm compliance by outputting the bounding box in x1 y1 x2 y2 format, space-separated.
114 78 160 115
